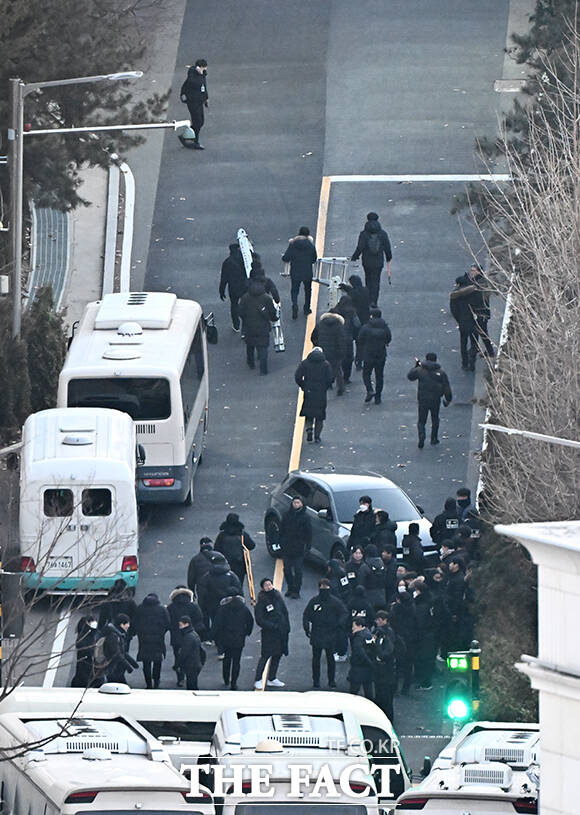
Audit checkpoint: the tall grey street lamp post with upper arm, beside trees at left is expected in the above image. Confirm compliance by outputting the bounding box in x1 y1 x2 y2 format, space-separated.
8 71 143 338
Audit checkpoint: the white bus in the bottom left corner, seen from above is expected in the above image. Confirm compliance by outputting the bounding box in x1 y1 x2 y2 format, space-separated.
0 713 215 815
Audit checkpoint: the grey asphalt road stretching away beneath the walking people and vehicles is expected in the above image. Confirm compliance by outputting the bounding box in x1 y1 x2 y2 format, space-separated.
28 0 509 780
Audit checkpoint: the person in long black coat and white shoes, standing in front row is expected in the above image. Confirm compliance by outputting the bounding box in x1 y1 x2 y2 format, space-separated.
254 577 290 688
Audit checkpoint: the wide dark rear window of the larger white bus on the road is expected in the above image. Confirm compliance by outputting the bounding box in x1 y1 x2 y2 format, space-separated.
68 377 171 421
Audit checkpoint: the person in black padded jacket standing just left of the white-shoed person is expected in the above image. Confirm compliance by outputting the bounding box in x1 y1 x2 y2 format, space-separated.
212 589 254 690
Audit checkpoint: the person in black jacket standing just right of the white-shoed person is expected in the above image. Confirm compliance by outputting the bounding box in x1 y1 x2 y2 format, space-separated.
302 577 347 688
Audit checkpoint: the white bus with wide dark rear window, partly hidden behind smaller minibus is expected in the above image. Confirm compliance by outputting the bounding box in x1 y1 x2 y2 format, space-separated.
58 292 209 503
